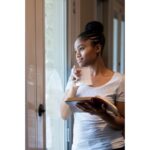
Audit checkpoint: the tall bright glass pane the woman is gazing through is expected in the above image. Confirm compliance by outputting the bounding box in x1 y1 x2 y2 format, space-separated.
45 0 66 150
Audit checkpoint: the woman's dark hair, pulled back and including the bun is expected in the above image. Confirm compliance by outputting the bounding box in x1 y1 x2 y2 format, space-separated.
78 21 105 54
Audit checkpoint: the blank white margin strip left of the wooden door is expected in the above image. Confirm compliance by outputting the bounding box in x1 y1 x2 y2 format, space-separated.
0 0 25 150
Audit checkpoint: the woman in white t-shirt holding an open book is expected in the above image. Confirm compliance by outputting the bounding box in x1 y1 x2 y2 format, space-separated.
61 21 124 150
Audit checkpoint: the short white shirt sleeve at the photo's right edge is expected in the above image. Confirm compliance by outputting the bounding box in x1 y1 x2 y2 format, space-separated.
116 75 125 102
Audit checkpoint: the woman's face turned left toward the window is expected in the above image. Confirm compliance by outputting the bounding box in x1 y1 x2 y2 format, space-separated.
74 39 98 67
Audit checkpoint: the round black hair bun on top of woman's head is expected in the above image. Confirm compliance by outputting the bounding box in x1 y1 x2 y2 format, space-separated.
85 21 104 34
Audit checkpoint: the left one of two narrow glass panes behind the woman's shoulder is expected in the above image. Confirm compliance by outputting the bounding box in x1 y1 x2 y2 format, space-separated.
113 18 118 71
